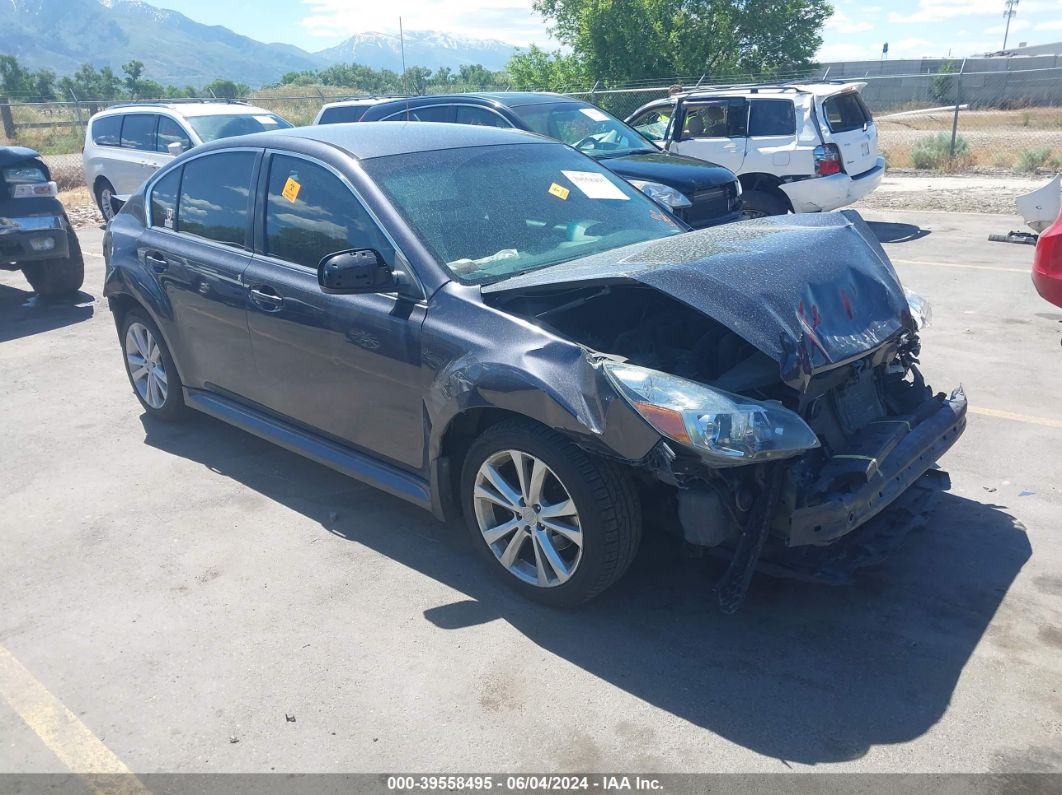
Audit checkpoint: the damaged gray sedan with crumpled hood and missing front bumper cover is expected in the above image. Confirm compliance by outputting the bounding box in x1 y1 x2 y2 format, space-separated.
104 123 966 610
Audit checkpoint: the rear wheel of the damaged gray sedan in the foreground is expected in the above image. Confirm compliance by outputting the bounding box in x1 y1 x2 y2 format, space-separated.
121 309 187 420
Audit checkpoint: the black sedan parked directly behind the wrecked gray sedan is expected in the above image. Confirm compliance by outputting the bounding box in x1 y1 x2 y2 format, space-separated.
329 91 741 229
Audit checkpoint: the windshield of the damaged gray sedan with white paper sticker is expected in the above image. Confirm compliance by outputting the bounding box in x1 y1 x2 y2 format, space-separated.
362 143 685 283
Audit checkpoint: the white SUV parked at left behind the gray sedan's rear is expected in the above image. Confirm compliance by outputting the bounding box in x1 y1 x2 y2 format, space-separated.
82 100 292 221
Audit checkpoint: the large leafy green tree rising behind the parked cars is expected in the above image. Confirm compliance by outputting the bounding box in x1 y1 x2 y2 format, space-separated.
526 0 833 84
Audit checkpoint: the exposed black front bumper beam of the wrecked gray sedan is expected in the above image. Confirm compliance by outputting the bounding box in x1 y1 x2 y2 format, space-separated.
775 387 966 547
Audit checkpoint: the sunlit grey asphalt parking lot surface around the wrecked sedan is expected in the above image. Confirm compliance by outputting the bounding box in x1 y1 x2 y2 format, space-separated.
0 211 1062 773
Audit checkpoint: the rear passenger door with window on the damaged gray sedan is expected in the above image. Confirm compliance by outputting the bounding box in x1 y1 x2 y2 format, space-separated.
137 149 261 397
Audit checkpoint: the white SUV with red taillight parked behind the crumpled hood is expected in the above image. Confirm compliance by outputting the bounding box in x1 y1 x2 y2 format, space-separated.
627 83 885 217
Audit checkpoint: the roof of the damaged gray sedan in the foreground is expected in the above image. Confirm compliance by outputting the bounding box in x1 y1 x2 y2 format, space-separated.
194 121 563 160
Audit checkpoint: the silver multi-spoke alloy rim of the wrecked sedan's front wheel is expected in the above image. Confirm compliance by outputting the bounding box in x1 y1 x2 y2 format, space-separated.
473 450 583 588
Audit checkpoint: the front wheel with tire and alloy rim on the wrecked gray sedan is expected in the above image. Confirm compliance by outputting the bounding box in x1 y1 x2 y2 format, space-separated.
461 419 641 607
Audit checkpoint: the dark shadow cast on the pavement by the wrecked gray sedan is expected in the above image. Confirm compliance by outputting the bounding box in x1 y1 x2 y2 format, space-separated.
142 416 1030 764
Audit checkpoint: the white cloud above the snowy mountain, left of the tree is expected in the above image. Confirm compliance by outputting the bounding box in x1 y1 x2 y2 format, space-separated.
303 0 556 48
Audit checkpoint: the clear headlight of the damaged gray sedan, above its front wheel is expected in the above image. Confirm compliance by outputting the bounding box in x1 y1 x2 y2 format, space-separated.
604 362 819 466
